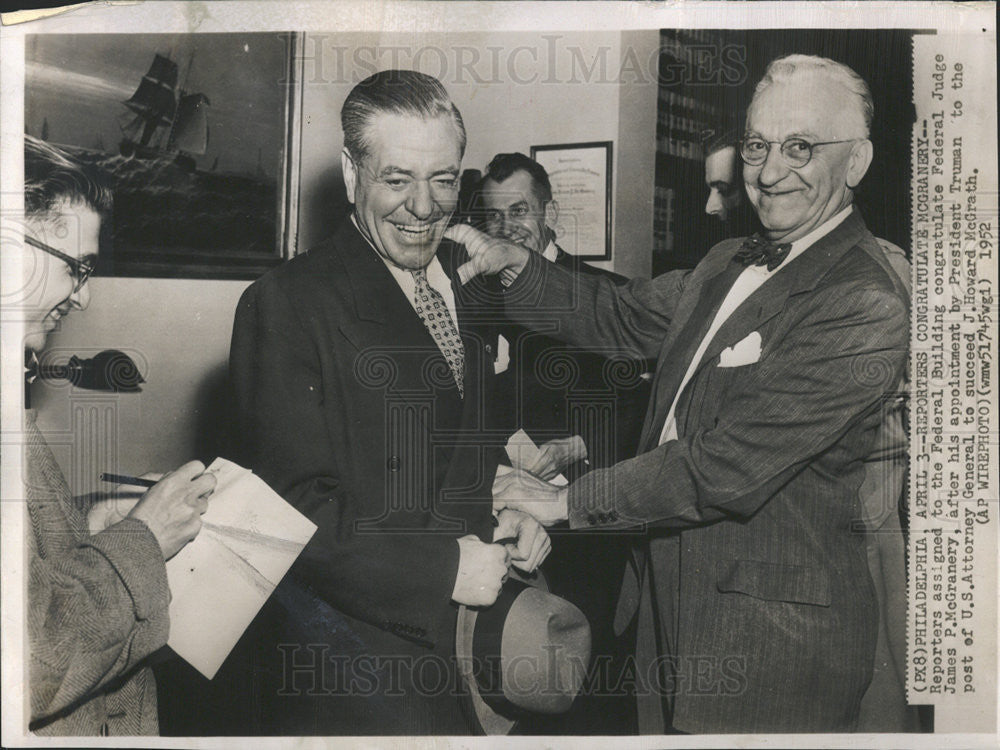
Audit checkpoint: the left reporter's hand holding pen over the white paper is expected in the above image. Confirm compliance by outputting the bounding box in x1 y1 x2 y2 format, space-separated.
128 461 215 560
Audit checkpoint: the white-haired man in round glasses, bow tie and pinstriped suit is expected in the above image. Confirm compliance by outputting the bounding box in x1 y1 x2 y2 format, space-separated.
449 55 909 733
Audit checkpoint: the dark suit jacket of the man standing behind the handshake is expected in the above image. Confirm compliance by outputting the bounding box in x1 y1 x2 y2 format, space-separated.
496 248 649 466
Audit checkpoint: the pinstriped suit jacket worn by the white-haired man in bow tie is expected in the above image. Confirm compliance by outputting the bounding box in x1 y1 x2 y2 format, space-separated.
508 210 909 733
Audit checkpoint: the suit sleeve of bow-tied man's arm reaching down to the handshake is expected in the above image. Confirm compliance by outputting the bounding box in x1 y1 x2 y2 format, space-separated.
569 284 909 528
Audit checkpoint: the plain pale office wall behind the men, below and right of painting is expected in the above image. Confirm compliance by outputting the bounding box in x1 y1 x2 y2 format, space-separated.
33 30 658 493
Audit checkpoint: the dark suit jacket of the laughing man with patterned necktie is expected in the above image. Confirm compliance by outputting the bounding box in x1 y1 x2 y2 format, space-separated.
230 222 502 734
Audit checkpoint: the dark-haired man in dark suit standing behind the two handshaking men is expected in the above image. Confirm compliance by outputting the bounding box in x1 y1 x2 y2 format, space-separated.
477 153 649 734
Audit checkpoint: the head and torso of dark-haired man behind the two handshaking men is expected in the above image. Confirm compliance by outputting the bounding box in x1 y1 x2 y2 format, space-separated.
479 153 649 478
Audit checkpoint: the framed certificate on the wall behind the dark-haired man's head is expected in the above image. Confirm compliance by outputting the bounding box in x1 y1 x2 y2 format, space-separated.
531 141 614 260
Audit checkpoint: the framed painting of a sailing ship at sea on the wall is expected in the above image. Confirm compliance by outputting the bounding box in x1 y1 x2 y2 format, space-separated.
25 33 300 279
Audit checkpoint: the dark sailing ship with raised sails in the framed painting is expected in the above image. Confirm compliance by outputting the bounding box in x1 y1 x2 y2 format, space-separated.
119 54 210 169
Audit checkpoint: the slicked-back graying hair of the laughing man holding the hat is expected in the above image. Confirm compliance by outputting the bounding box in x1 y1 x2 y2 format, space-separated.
340 70 466 160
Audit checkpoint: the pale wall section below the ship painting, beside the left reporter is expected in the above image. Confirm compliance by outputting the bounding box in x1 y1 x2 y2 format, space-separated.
32 278 250 494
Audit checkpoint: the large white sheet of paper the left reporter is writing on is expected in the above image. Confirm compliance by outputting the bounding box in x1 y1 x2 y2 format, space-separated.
167 458 316 679
